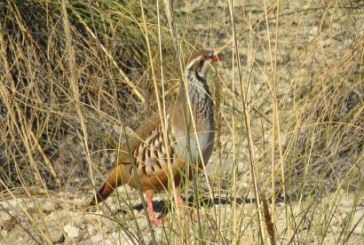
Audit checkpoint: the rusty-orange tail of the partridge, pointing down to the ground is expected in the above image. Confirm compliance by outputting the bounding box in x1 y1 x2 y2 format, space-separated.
89 165 123 207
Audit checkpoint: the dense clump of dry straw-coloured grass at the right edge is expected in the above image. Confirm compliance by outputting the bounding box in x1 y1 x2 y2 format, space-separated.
278 38 364 196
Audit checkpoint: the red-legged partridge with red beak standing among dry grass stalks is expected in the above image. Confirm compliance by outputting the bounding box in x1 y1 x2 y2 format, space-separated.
89 53 220 225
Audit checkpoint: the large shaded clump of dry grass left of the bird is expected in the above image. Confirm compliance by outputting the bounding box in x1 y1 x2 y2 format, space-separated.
0 0 175 190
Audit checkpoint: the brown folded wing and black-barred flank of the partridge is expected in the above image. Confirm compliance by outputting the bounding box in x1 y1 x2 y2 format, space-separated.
123 110 184 190
